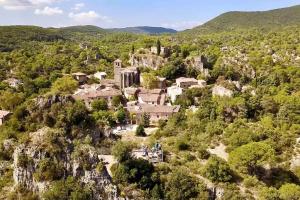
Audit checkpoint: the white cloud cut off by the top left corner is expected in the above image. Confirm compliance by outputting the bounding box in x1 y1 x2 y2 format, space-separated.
0 0 60 10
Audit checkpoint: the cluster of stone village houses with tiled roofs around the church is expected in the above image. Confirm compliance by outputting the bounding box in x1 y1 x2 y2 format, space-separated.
0 47 239 128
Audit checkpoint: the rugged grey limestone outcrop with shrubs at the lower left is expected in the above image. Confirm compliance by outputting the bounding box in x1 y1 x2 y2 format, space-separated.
13 128 119 200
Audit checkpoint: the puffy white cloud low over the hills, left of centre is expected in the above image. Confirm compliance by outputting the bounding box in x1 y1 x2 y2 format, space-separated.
69 10 112 24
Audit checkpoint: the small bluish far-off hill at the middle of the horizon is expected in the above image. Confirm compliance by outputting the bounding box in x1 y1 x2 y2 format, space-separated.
108 26 177 35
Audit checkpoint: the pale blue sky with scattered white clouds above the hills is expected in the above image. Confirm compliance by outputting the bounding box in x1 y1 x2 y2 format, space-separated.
0 0 300 30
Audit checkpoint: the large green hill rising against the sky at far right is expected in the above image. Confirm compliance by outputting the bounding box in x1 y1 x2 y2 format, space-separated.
188 5 300 33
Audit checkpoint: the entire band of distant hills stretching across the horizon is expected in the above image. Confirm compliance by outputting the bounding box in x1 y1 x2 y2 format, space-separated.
0 5 300 37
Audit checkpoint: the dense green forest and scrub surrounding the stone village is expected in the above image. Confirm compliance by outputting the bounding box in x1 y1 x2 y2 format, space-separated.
0 6 300 200
